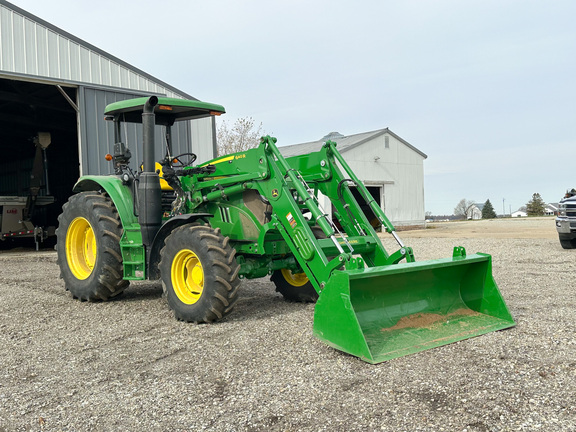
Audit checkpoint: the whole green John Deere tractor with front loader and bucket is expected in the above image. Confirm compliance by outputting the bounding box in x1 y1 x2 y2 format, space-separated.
57 96 515 363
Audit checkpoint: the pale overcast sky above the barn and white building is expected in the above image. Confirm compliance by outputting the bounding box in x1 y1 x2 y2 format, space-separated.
12 0 576 215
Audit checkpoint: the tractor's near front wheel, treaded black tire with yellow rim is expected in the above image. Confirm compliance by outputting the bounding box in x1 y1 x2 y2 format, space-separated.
159 225 240 323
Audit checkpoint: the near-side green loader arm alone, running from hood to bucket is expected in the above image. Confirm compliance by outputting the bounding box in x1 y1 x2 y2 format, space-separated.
182 137 351 292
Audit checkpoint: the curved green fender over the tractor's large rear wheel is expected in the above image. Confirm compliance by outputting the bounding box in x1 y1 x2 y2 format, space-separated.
72 175 138 229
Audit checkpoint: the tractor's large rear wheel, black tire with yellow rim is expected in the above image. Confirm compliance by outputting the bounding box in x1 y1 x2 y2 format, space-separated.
56 191 129 301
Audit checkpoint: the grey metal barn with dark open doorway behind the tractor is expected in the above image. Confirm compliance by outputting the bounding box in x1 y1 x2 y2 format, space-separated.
0 0 216 240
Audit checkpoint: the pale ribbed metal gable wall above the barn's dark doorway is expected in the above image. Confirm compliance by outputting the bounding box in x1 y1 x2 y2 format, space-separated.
0 0 195 99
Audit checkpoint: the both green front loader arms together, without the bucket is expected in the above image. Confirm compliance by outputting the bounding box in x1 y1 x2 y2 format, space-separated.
182 136 414 293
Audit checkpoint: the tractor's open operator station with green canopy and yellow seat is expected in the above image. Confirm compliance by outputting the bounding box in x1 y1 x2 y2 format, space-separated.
104 96 226 247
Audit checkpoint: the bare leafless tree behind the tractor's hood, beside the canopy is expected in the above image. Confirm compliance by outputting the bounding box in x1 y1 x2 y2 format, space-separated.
216 117 265 156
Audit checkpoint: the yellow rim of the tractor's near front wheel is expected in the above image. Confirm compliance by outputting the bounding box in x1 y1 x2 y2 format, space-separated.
171 249 204 304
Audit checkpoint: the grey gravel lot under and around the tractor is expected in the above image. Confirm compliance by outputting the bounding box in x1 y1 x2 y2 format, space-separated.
0 218 576 432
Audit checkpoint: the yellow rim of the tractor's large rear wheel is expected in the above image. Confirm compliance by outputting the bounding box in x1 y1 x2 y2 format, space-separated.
66 217 97 280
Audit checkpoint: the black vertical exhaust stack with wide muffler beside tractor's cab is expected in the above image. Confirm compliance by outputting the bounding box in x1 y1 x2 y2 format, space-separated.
138 96 162 249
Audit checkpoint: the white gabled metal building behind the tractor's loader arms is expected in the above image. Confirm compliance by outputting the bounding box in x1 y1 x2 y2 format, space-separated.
279 128 427 228
